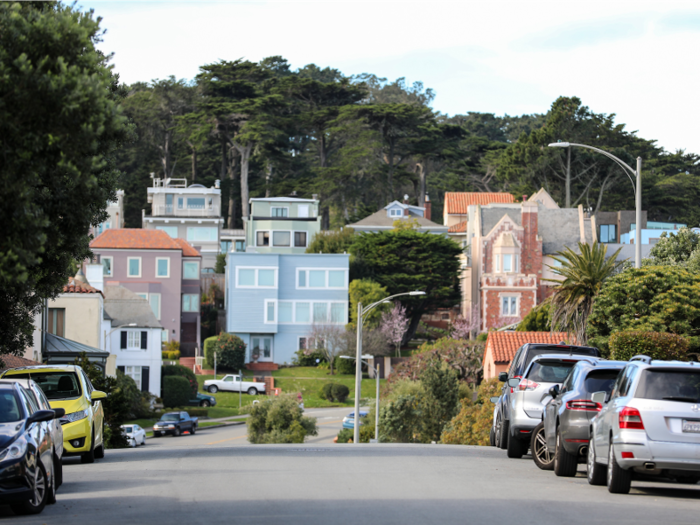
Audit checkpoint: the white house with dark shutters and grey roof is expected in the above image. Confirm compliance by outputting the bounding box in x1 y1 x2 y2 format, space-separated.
103 285 163 397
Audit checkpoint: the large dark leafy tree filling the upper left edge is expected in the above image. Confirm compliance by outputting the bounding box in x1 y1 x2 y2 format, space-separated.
0 0 130 355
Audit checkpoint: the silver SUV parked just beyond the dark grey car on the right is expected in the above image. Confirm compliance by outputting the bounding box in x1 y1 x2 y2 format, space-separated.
506 354 595 458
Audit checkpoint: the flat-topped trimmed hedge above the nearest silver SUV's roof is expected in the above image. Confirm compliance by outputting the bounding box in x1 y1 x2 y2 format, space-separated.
609 332 689 361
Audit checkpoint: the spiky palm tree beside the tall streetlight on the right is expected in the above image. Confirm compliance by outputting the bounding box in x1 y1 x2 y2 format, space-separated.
544 242 623 344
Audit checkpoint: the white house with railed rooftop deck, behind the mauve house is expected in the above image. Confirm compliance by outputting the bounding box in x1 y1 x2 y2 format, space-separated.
141 176 224 271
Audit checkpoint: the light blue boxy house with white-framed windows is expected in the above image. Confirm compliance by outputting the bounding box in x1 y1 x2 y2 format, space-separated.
226 252 350 369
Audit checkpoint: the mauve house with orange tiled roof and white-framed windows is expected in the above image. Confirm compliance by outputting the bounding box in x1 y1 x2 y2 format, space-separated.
90 228 202 357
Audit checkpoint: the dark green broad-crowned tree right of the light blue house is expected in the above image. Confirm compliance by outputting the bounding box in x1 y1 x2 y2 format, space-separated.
350 230 462 344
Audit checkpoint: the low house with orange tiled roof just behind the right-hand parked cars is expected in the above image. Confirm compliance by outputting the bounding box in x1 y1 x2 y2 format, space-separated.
483 331 570 381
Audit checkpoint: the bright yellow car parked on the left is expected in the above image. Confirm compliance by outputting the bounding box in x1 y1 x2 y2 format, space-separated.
0 365 107 463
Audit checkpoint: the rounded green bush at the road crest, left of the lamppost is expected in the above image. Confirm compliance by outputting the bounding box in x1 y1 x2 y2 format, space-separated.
247 396 318 444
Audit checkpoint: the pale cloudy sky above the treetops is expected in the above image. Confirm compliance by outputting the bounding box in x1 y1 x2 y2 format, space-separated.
79 0 700 154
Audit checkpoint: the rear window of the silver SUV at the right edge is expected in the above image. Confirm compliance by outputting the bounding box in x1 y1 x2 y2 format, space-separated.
634 369 700 403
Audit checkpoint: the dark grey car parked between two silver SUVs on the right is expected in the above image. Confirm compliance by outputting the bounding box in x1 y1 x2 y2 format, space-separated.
530 360 627 477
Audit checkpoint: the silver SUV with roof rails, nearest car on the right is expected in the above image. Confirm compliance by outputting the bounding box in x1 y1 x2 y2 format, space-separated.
588 356 700 494
